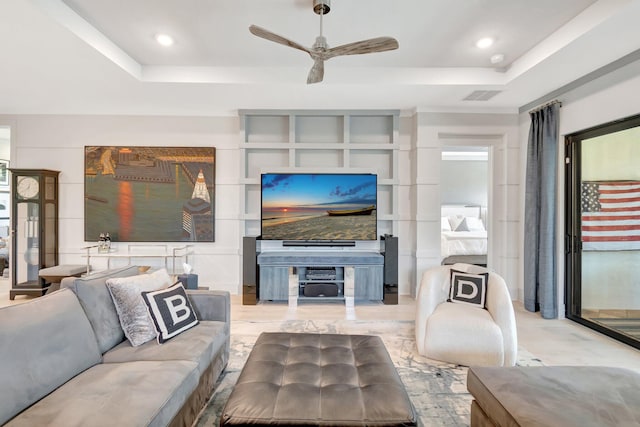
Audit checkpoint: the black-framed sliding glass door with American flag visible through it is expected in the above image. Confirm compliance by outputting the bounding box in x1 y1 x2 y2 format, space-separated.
566 116 640 348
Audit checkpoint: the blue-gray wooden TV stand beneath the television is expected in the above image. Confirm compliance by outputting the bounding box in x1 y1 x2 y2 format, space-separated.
257 251 384 301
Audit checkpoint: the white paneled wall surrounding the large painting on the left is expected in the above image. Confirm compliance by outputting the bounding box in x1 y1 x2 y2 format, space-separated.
0 116 242 293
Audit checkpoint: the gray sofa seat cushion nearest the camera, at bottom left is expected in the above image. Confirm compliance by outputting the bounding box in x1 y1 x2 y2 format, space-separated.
7 360 199 427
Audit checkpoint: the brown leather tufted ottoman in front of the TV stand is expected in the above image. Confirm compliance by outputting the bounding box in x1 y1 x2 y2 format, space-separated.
220 332 417 426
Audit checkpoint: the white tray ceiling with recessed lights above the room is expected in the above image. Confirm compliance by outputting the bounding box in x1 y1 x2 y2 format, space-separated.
0 0 640 115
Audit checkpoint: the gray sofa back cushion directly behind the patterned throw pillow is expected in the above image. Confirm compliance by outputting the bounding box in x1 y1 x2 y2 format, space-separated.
61 265 138 353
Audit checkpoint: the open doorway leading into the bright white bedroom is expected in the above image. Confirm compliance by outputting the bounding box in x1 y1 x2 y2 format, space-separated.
440 145 490 267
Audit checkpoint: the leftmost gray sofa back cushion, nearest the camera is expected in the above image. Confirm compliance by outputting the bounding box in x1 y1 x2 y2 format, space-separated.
0 289 101 425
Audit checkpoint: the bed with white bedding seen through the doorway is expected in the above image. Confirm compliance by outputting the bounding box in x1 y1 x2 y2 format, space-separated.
440 205 487 266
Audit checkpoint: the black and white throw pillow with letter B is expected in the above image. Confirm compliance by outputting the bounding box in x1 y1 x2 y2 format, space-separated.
142 282 198 344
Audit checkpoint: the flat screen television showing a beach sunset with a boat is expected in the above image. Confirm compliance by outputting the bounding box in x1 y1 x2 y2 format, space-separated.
260 173 378 241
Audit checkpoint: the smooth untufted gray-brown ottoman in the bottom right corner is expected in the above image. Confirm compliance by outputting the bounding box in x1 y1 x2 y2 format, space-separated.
467 366 640 427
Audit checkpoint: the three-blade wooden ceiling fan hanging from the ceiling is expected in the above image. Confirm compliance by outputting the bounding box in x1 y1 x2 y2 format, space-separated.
249 0 398 84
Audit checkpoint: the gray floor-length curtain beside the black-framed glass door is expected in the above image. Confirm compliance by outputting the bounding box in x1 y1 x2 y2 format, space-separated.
524 102 560 319
